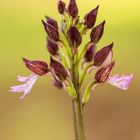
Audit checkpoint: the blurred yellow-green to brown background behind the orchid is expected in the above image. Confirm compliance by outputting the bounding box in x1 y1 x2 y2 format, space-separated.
0 0 140 140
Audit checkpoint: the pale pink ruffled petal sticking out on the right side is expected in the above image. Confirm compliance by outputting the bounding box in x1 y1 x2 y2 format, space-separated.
107 74 133 90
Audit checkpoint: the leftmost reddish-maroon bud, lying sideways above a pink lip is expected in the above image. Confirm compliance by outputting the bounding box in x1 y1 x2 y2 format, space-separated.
23 58 49 76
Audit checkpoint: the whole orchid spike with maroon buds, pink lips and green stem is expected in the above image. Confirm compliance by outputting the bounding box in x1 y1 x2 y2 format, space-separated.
10 0 133 140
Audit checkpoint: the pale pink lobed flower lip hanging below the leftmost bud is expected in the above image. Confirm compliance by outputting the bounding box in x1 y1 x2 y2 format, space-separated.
10 74 39 99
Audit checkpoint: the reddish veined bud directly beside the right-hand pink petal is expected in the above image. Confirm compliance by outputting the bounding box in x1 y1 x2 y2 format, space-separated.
95 61 115 83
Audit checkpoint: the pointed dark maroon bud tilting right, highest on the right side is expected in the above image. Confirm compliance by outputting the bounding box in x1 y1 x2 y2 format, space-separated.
84 5 99 28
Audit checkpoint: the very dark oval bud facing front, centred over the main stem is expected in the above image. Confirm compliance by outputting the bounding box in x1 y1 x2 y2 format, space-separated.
67 26 82 48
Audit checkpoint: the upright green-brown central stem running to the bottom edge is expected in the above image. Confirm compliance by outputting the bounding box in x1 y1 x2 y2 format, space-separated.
71 54 85 140
